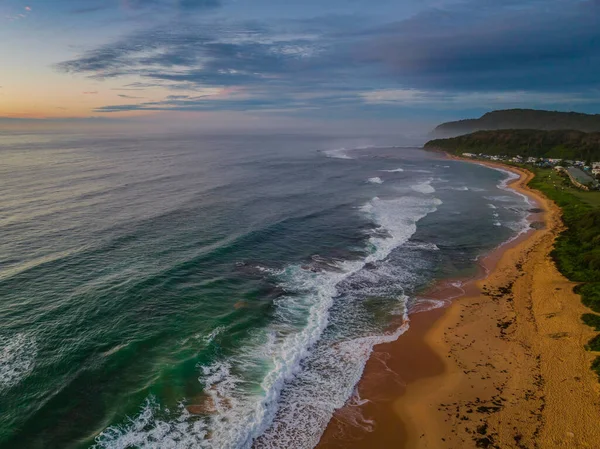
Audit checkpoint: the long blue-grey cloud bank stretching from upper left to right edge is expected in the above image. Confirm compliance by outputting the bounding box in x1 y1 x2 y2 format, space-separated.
58 0 600 111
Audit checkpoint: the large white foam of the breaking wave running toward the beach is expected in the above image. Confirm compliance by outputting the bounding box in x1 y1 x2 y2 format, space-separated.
95 196 441 449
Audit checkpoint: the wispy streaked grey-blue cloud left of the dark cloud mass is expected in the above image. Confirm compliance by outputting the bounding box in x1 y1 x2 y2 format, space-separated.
58 22 335 86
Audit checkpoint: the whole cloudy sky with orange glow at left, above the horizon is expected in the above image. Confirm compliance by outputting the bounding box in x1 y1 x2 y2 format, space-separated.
0 0 600 130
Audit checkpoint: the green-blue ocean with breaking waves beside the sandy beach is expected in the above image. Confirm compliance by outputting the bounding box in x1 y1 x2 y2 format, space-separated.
0 133 531 449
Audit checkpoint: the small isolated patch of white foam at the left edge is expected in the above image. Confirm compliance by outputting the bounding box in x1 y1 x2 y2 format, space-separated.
0 333 37 391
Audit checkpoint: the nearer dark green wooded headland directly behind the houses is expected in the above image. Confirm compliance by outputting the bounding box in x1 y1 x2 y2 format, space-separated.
425 128 600 161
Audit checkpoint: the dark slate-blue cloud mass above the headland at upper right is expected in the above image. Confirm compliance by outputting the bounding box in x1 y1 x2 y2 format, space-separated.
360 0 600 90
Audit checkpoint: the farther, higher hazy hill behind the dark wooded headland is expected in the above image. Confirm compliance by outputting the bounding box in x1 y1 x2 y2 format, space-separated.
432 109 600 137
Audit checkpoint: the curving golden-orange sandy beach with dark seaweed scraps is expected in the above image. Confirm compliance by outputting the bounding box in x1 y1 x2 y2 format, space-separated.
318 158 600 449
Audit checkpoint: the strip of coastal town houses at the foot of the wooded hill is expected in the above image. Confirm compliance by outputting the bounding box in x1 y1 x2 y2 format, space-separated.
462 153 600 190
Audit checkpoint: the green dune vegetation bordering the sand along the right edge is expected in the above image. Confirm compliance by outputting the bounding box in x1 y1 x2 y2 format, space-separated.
529 169 600 377
